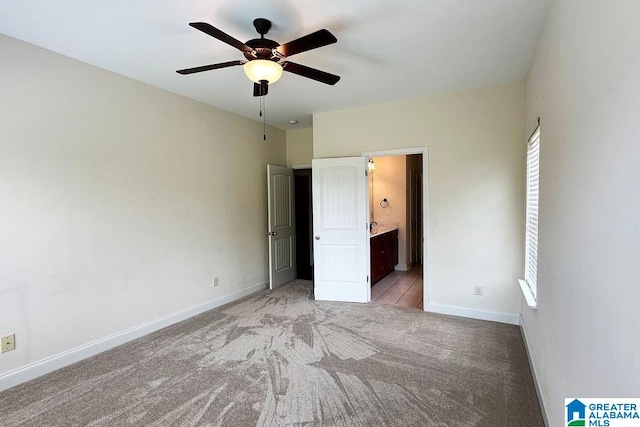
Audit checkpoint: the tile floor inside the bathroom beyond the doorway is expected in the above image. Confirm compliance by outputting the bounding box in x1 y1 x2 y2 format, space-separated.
371 264 422 309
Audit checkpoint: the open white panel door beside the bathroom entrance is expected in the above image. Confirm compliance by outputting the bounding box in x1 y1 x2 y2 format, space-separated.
312 157 371 302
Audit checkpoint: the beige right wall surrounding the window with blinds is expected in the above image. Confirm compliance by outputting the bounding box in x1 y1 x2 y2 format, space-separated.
522 0 640 426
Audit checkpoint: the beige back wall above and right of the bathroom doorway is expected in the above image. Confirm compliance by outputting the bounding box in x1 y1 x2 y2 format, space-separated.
313 84 525 318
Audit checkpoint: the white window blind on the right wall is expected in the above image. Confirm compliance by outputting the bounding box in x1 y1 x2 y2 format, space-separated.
524 125 540 298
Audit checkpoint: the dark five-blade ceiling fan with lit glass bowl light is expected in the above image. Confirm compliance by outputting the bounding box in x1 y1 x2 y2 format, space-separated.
177 18 340 96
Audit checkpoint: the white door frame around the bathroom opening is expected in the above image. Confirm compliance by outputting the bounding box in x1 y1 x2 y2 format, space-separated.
360 146 431 311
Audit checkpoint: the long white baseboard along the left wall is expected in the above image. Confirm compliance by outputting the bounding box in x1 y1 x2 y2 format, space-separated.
0 282 269 391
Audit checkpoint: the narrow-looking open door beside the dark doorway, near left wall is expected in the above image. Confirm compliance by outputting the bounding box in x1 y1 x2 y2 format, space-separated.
267 165 296 289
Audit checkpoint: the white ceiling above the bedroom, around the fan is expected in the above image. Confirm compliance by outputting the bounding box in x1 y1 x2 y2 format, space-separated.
0 0 551 130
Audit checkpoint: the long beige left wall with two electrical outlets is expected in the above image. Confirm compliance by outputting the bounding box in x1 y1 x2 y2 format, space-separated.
0 36 286 374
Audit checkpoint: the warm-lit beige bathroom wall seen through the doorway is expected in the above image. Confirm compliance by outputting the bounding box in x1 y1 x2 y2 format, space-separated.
369 156 407 270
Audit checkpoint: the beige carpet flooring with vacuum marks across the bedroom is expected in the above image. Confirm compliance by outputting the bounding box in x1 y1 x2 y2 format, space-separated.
0 281 543 427
